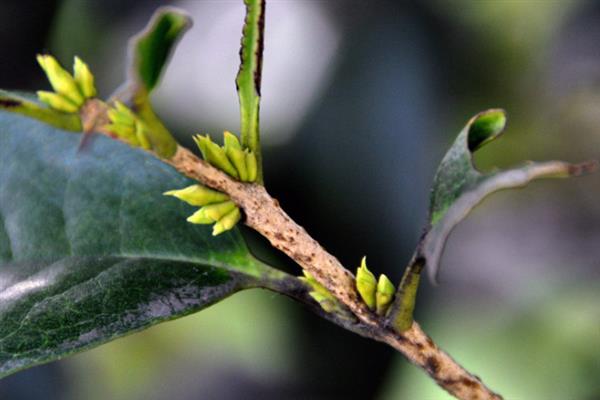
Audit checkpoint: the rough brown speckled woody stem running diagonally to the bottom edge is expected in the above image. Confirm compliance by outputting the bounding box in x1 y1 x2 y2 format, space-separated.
166 147 501 399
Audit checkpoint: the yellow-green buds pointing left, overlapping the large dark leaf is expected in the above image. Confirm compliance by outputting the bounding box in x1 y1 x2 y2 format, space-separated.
164 185 241 236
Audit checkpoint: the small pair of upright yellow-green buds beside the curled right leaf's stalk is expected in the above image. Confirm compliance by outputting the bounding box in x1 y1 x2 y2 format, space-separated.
356 257 396 315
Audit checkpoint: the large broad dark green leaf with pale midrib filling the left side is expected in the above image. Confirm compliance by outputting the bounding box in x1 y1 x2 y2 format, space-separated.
0 112 284 376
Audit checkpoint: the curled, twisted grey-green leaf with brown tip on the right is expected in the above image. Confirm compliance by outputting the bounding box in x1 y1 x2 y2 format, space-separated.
418 109 596 281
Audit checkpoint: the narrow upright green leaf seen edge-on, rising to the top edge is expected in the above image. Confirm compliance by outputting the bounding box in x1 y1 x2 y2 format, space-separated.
235 0 265 183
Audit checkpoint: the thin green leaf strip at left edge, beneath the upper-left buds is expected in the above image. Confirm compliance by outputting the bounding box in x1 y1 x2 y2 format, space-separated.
0 90 82 132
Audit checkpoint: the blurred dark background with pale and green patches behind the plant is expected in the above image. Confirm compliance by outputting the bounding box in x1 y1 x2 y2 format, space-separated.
0 0 600 400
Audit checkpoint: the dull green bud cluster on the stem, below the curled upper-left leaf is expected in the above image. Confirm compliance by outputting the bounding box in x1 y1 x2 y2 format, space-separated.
104 101 151 150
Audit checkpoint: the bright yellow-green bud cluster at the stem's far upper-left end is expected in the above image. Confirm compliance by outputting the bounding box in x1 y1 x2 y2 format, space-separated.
37 55 96 113
